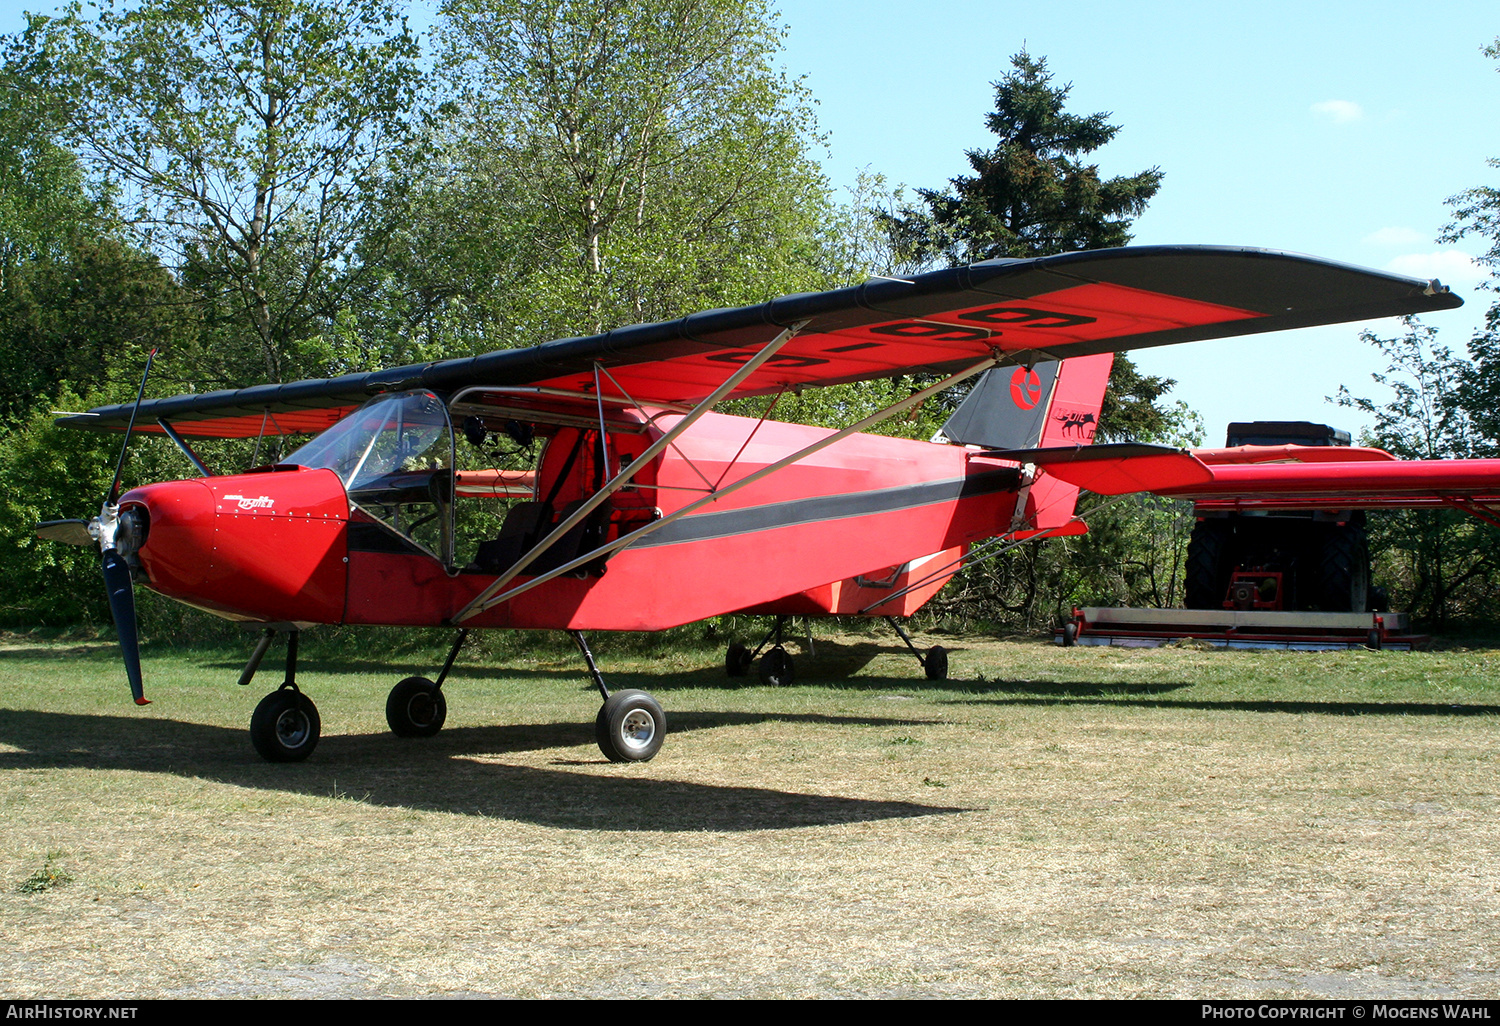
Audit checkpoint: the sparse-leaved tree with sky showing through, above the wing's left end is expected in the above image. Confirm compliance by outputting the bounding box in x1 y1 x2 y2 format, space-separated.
33 0 420 381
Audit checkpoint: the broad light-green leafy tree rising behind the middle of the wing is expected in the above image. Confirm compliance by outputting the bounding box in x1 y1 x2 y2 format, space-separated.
370 0 833 356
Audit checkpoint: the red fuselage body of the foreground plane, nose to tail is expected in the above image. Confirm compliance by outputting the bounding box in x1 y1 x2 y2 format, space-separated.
122 414 1056 630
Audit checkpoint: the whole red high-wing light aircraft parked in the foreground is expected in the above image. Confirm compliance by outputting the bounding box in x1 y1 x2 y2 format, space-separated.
39 246 1461 761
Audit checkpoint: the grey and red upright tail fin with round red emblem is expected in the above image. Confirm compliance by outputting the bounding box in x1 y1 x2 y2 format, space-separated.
942 353 1115 531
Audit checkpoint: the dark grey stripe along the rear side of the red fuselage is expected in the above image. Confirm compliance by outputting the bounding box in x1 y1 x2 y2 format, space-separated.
632 468 1020 549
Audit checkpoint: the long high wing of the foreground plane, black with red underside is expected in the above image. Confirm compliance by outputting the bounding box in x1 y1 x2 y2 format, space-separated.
59 246 1463 438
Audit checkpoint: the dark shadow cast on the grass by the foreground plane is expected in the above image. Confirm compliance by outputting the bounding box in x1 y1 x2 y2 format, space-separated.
0 710 975 833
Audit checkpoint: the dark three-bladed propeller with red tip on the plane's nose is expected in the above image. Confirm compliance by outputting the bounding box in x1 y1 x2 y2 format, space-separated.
36 350 156 705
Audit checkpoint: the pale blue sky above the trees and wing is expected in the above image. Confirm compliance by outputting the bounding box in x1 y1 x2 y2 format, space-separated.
0 0 1500 444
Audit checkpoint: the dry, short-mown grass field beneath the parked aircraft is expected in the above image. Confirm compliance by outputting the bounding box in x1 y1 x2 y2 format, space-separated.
0 633 1500 998
